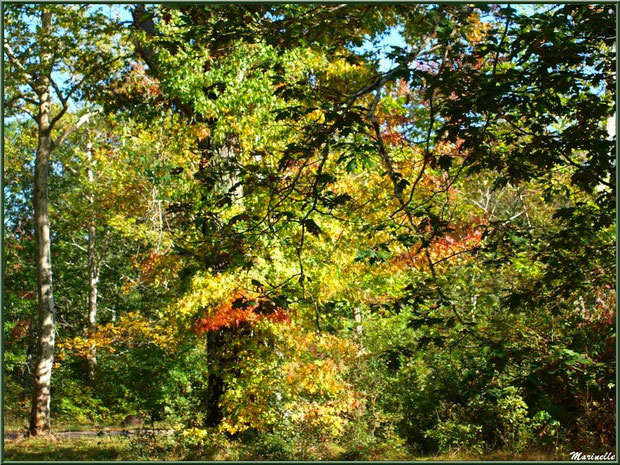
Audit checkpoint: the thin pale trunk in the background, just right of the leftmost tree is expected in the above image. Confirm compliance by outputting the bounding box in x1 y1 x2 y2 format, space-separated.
88 144 99 379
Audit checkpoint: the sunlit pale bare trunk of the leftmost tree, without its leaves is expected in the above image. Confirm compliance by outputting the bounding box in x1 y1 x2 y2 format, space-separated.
29 11 56 435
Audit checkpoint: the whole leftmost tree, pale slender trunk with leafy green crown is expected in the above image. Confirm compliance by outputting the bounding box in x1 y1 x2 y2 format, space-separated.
4 5 120 435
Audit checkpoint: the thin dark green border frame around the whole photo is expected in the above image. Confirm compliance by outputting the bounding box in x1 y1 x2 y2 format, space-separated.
0 0 620 464
